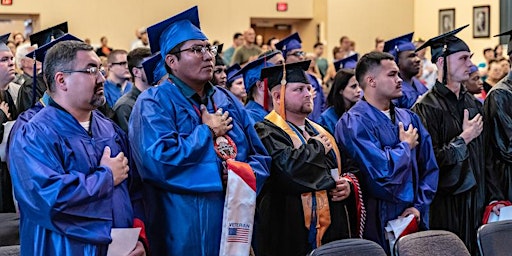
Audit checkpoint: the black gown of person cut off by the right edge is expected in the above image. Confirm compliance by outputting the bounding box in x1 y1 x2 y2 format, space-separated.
484 73 512 201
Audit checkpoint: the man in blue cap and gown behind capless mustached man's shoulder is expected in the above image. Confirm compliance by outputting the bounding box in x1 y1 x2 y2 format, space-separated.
384 33 428 109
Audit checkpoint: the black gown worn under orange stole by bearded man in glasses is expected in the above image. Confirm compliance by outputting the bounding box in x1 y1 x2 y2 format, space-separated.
253 120 359 256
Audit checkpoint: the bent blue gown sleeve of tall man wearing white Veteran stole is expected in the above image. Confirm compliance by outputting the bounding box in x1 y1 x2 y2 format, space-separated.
129 94 223 193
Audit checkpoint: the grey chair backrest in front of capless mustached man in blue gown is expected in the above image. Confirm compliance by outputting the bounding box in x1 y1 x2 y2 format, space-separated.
395 230 470 256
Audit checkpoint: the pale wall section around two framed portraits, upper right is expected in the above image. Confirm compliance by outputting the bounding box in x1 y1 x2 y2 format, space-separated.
414 0 500 64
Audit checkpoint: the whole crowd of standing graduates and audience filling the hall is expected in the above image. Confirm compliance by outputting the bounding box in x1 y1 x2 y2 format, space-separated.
0 4 512 255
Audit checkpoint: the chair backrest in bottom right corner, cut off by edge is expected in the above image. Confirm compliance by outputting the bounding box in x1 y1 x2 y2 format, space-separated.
478 220 512 256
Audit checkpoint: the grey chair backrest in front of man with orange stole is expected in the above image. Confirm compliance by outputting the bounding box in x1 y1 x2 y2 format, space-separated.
310 238 386 256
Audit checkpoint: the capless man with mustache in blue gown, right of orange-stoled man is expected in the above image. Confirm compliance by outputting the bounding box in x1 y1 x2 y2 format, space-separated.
335 52 439 252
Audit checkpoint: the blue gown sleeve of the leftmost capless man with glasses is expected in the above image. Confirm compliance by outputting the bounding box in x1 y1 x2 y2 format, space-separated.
9 123 114 243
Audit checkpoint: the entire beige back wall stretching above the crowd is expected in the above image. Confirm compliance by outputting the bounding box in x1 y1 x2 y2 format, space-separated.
0 0 499 65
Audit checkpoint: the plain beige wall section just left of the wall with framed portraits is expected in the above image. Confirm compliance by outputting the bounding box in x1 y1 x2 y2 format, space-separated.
326 0 416 59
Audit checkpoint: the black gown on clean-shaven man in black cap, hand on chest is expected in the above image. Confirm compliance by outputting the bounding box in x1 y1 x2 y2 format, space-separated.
412 81 486 255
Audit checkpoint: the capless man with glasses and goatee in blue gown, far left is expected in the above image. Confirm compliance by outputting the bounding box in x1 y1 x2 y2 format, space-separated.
9 41 144 256
